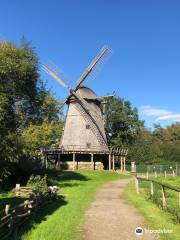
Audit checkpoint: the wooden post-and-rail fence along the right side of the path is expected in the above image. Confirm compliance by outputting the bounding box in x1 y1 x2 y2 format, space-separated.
135 176 180 209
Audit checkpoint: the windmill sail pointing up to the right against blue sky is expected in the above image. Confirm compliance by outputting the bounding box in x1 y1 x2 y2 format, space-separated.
75 45 112 91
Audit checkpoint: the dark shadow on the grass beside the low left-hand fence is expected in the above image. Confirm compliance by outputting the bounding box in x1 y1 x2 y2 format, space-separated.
17 196 67 240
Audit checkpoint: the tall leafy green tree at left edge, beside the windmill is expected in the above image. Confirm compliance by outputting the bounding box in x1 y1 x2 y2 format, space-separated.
0 39 62 182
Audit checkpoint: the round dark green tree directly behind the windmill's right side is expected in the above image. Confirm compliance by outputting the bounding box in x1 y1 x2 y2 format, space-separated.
105 97 143 146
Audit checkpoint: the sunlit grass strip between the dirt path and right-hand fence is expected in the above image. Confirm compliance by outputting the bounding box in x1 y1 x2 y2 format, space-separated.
124 178 180 240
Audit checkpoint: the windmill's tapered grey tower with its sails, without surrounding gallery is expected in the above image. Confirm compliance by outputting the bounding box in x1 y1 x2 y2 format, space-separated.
43 46 112 168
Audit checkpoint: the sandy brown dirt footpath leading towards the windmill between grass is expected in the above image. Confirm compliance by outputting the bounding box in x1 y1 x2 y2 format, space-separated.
81 179 158 240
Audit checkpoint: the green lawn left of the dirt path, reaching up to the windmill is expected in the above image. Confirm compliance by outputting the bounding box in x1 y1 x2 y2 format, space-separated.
0 170 126 240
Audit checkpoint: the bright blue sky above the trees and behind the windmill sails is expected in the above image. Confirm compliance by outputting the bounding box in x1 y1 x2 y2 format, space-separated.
0 0 180 128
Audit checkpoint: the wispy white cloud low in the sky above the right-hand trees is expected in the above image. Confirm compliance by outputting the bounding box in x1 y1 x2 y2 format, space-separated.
140 105 180 122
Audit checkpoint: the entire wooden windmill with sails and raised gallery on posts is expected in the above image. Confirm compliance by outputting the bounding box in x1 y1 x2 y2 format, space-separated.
43 46 127 171
